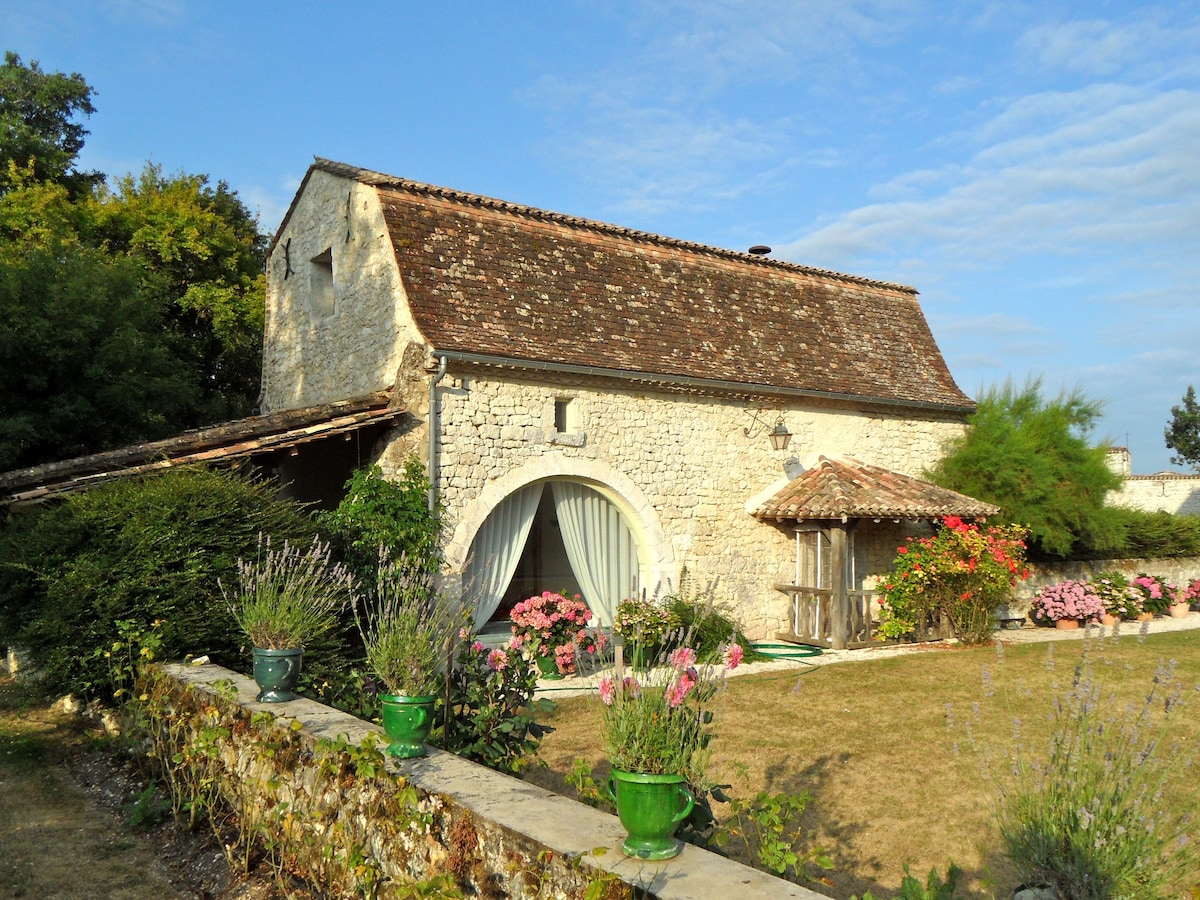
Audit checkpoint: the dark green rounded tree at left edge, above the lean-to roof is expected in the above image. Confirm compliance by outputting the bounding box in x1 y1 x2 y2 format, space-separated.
0 184 196 470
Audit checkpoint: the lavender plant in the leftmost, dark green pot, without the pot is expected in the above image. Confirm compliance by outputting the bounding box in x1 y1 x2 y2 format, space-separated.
221 534 354 650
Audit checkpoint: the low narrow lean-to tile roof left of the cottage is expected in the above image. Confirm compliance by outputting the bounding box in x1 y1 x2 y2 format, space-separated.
0 392 407 504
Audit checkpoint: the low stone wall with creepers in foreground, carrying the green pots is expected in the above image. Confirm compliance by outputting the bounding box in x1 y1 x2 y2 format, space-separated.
155 665 823 900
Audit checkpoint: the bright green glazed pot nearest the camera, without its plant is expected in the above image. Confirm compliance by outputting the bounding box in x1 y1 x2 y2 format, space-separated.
605 769 696 859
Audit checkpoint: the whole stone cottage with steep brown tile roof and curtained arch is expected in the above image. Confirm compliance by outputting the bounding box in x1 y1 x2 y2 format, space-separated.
262 160 990 643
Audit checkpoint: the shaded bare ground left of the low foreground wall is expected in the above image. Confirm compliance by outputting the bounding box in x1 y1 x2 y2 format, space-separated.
0 677 179 900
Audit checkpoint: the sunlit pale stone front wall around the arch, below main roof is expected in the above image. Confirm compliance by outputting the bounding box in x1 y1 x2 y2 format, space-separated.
380 368 962 637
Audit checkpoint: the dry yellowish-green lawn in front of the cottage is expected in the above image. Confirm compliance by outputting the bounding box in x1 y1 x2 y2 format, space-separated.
530 631 1200 898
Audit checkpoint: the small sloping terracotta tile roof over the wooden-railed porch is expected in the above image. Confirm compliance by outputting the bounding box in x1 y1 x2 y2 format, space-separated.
754 456 1000 520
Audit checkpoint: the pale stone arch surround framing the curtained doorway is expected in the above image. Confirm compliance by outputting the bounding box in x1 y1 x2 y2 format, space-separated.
445 454 676 590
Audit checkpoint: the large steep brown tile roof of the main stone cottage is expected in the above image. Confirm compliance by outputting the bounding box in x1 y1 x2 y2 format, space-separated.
300 160 974 412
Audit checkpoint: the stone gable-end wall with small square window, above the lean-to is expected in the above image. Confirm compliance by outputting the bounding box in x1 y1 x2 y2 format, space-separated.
262 170 420 413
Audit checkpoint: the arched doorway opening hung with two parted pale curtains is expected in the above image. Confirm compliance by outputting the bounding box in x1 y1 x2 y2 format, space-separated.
463 479 643 629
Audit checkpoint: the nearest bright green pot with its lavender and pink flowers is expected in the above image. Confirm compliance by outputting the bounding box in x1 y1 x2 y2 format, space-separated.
599 644 743 859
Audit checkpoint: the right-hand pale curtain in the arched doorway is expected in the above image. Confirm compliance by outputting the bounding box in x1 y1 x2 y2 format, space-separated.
551 481 638 625
